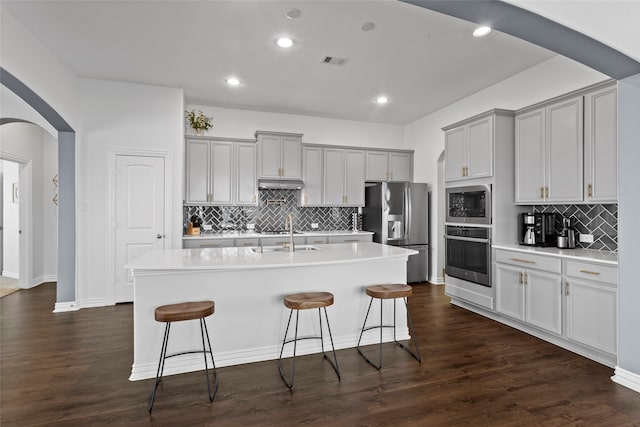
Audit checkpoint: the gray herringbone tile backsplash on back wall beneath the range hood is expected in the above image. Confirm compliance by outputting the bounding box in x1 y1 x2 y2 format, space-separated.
182 190 358 231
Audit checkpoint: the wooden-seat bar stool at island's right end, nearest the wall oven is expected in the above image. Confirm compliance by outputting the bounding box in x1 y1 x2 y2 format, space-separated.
357 285 422 370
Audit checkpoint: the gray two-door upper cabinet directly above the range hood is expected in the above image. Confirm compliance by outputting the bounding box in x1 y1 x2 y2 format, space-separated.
256 131 302 179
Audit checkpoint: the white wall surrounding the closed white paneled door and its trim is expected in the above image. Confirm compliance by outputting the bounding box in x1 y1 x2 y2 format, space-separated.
76 79 184 306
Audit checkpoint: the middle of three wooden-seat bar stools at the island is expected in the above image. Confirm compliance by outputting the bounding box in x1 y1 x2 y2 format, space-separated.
278 292 340 390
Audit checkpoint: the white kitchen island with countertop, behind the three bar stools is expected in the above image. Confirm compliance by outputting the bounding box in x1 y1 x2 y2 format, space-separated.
126 243 417 380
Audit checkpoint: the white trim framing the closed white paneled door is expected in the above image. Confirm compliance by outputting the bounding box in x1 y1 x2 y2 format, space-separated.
106 147 173 305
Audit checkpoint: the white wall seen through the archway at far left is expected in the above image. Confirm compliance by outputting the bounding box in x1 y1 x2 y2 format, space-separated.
0 123 58 286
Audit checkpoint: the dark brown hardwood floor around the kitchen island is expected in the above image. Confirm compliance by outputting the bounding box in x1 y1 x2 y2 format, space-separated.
0 284 640 427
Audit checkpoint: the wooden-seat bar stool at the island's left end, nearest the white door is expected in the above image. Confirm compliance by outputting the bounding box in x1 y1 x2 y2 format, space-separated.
149 301 218 413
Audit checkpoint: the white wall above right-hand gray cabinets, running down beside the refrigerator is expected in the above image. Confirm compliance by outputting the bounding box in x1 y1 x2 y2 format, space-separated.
404 56 607 283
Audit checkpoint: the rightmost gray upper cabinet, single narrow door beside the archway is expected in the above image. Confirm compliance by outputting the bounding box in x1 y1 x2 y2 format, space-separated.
584 85 618 203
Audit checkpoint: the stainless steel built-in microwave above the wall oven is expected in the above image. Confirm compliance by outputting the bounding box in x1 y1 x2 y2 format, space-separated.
446 184 491 224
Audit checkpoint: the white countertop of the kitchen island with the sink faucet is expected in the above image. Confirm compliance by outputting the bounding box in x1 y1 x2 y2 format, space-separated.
125 242 418 271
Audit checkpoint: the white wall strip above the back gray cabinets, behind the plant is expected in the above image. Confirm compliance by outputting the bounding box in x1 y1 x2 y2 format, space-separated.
185 105 404 149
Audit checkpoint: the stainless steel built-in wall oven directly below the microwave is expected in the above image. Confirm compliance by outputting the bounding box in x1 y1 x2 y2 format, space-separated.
445 225 491 287
